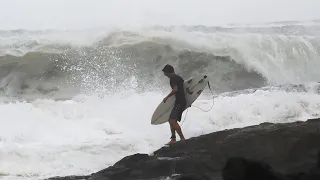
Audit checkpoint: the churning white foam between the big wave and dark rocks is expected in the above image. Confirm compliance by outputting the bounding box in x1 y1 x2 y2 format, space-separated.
0 88 320 179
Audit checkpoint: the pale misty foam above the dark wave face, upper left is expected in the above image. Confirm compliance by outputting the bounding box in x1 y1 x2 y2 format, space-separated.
0 28 112 56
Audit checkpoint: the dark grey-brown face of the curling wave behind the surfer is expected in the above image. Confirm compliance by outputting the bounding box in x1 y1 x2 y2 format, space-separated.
0 44 264 98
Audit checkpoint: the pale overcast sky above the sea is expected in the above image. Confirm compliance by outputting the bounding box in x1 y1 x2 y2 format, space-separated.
0 0 320 29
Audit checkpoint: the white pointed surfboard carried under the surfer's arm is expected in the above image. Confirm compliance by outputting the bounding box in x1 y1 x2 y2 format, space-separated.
151 74 209 125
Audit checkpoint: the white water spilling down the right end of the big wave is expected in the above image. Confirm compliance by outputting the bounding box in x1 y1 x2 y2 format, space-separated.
139 28 320 85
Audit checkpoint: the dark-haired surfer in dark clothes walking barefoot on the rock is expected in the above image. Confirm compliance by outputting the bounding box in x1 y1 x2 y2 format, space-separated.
162 64 186 144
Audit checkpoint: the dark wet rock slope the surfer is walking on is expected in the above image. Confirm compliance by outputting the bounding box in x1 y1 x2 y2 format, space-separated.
48 119 320 180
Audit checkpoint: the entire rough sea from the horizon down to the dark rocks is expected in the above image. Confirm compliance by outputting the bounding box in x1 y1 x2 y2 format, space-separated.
0 1 320 180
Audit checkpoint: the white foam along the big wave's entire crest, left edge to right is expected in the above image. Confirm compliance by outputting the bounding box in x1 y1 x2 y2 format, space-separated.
0 28 320 85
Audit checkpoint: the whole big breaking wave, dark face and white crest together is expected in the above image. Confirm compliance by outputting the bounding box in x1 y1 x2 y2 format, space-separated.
0 26 320 96
